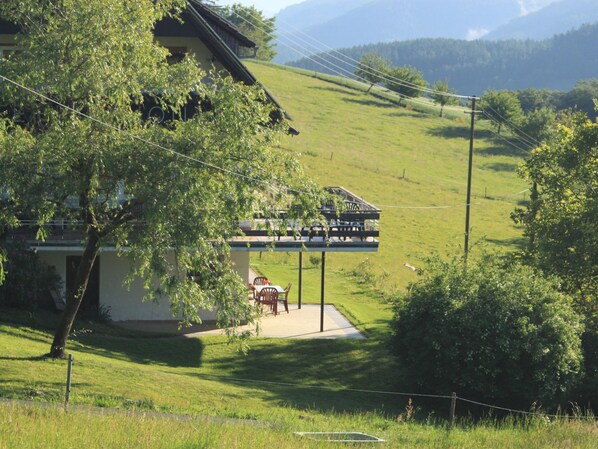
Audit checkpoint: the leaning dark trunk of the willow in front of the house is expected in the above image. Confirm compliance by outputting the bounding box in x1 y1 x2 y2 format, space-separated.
48 233 100 359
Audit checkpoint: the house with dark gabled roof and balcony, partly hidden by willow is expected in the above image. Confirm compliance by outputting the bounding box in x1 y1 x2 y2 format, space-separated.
0 0 380 321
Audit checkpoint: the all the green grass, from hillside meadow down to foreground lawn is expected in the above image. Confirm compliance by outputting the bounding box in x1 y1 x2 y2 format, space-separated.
0 64 596 449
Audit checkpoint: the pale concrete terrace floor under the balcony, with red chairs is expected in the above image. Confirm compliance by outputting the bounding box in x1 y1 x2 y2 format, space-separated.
117 304 365 339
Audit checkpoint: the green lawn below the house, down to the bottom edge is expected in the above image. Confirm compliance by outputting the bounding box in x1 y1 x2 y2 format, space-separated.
0 316 596 449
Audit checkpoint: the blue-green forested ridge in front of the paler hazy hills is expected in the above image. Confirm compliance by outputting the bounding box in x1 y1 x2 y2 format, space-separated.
289 23 598 95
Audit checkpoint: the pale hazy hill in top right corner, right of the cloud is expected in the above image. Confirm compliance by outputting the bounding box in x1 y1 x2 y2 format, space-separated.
483 0 598 39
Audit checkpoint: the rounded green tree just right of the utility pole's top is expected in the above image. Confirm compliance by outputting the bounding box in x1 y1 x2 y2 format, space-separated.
479 89 523 134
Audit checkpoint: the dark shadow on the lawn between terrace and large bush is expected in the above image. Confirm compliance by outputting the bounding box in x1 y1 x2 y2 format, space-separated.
196 339 404 413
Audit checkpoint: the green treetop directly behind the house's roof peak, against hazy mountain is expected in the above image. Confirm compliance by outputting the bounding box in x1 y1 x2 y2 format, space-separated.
218 3 276 61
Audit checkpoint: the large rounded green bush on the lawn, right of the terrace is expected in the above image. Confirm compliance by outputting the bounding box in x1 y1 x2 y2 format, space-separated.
392 255 582 408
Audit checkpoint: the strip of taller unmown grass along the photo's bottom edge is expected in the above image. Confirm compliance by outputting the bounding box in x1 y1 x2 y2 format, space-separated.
0 403 598 449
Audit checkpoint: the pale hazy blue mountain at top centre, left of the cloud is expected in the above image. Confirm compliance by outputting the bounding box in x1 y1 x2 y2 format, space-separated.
275 0 564 62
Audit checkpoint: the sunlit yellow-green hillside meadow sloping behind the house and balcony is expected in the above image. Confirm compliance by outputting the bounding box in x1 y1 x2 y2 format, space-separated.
248 62 527 288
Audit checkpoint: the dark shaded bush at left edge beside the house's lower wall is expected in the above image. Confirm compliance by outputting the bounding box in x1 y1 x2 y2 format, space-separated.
0 244 61 309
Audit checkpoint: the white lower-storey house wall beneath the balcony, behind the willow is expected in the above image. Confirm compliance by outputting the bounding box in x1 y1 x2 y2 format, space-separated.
38 248 249 321
